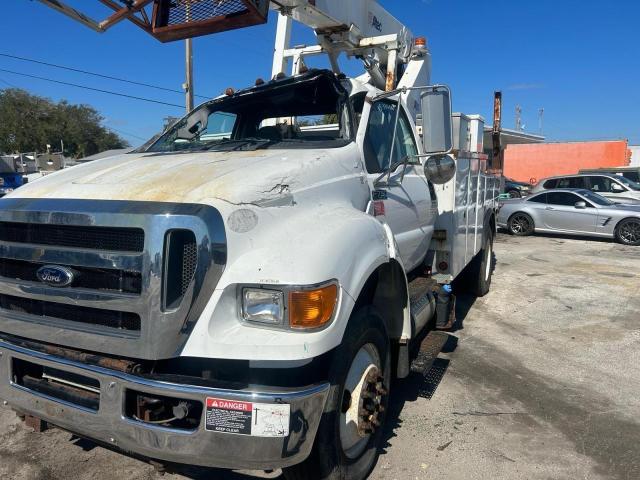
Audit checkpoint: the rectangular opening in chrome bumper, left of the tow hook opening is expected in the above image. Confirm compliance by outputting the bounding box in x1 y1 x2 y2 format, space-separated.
11 358 100 412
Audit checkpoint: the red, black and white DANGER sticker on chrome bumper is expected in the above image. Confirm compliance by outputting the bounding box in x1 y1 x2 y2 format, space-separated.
206 398 291 437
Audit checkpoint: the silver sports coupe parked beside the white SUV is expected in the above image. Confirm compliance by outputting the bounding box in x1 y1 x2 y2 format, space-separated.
498 189 640 245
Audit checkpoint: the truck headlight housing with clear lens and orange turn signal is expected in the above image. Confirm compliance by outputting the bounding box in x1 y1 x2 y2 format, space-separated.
240 281 339 331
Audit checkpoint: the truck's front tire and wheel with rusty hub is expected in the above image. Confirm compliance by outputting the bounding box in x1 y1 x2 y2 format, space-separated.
283 307 391 480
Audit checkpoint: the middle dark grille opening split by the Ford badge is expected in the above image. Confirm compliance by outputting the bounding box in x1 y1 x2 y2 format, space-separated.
0 258 142 294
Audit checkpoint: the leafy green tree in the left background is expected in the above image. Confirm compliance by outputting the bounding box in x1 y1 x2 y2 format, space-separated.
0 89 128 158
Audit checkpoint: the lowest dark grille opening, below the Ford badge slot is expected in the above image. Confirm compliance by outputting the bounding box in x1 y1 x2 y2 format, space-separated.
0 294 140 332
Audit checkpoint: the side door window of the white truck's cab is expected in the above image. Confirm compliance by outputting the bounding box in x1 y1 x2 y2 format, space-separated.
364 100 418 173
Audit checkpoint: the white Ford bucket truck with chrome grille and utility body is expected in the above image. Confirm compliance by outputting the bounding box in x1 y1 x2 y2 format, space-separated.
0 0 499 479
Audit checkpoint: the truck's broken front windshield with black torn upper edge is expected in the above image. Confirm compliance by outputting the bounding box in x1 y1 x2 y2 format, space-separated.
146 73 352 152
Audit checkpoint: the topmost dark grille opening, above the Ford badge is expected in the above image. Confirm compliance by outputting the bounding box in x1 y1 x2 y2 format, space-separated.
0 222 144 252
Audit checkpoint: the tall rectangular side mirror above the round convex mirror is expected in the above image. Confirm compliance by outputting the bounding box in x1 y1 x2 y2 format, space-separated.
420 85 453 155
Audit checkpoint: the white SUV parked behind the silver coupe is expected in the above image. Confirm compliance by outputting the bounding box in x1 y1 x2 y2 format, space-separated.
533 173 640 204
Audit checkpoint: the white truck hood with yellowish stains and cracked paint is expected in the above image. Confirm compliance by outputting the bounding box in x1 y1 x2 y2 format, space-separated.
11 149 356 206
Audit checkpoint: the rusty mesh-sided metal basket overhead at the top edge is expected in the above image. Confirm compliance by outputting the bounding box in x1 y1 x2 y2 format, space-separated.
153 0 270 42
